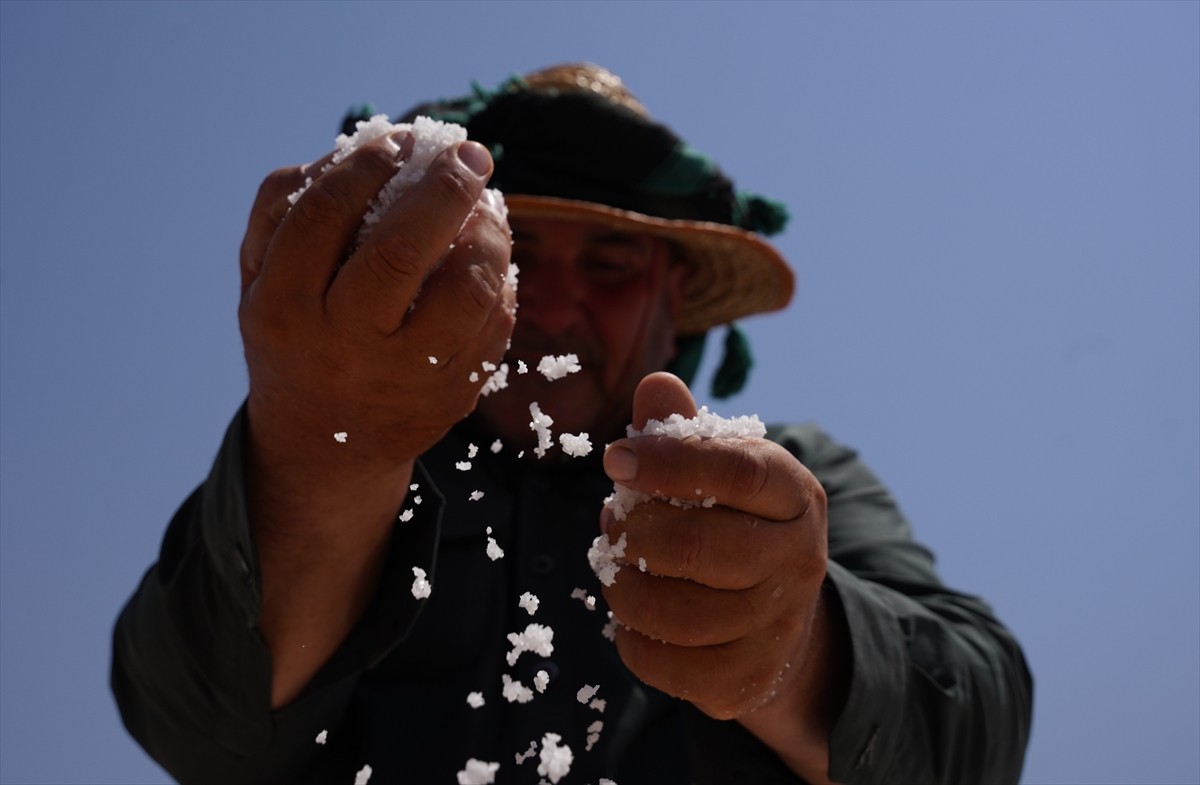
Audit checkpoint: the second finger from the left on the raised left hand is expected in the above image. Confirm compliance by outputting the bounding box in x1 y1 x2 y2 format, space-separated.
259 138 401 301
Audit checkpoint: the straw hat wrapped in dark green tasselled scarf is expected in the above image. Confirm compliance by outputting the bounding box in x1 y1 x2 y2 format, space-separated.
396 64 794 335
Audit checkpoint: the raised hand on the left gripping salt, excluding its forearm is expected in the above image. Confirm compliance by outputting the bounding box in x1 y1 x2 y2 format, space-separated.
239 137 515 471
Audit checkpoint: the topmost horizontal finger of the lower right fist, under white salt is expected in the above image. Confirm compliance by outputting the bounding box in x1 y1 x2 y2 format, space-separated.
604 436 820 521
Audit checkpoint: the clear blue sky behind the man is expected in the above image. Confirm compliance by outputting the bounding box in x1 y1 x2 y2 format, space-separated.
0 1 1200 783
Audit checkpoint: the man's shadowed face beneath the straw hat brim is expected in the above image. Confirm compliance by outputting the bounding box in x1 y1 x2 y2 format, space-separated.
476 218 684 450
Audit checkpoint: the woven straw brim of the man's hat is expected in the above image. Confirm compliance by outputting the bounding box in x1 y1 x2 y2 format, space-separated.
504 193 796 335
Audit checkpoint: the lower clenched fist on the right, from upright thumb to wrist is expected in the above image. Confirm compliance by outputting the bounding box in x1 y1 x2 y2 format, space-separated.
601 373 827 719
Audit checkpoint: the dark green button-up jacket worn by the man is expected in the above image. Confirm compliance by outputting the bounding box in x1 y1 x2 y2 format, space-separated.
112 413 1032 785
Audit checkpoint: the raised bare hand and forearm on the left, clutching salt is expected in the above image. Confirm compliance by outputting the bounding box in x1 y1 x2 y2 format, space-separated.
239 132 516 707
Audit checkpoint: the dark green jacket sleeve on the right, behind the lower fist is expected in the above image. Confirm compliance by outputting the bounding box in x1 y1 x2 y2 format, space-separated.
684 425 1032 785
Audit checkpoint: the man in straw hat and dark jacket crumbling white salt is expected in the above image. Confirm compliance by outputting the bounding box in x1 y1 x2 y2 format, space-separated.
113 65 1031 785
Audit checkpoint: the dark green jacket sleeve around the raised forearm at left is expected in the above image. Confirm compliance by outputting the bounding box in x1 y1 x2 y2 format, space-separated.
110 408 440 783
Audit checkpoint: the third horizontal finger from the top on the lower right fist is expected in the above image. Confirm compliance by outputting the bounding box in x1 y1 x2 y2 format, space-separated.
601 568 777 647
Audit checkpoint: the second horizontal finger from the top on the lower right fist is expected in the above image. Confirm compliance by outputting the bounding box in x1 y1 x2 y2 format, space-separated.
602 501 824 589
